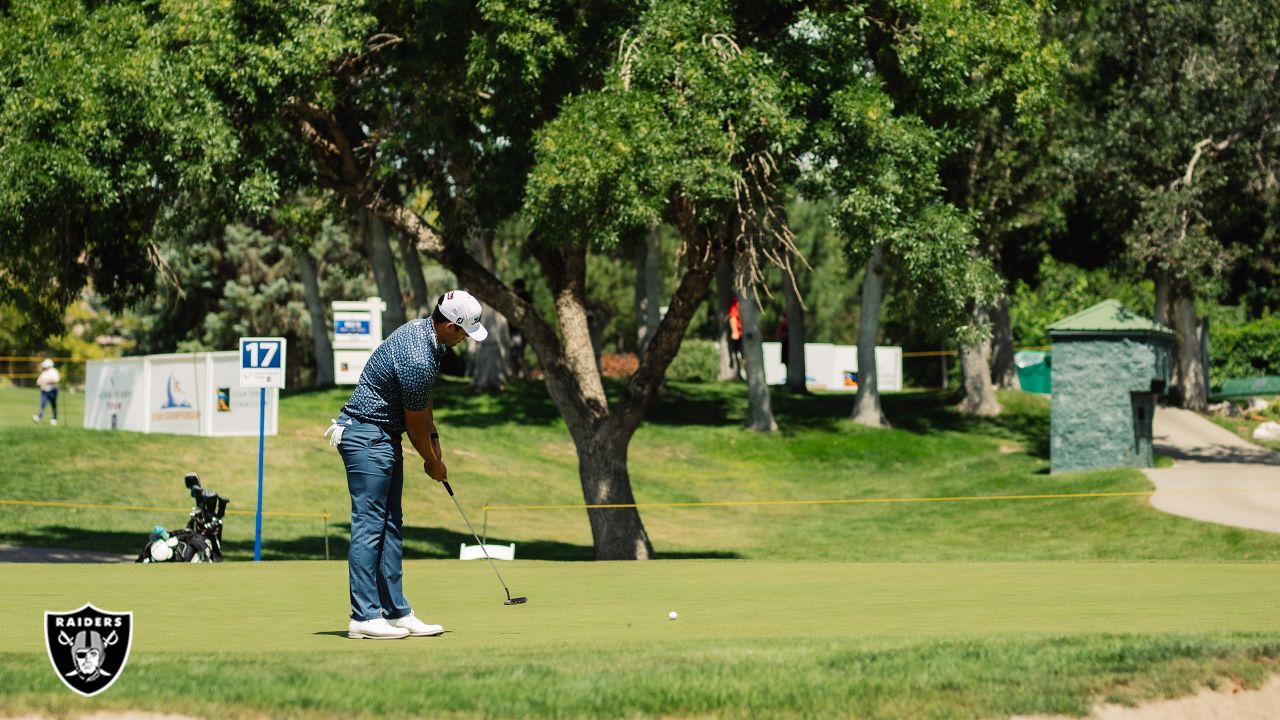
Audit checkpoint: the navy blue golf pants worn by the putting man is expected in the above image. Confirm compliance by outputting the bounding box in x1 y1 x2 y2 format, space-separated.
338 414 411 620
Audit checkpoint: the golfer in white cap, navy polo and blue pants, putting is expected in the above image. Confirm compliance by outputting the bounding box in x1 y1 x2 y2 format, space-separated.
325 290 489 639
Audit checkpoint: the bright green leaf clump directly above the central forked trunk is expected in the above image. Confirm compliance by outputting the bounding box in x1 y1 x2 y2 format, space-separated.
525 0 800 246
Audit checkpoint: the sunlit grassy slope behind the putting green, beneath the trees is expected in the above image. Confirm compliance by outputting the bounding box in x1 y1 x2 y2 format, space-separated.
0 382 1280 561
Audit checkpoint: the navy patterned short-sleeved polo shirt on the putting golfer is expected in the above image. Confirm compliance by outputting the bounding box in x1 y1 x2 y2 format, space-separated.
342 319 444 434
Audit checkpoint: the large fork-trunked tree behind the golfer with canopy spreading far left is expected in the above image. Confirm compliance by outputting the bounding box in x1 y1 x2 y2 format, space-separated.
4 0 797 559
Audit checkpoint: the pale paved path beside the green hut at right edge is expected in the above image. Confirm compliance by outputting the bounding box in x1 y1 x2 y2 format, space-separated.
1143 407 1280 533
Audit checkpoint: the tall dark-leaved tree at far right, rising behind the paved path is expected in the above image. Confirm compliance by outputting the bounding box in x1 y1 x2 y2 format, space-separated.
1059 0 1280 410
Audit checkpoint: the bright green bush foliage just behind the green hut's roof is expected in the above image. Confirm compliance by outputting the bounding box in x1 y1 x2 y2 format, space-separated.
1009 256 1157 347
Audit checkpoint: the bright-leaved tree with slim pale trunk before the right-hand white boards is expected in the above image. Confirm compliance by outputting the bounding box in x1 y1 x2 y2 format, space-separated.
792 3 1044 424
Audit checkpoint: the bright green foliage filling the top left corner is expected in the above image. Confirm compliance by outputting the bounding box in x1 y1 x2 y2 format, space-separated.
0 0 369 338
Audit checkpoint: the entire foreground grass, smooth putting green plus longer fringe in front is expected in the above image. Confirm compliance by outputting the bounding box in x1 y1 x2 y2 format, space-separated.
0 560 1280 717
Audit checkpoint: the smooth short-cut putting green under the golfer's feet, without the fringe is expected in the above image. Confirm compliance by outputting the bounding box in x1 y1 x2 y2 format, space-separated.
0 560 1280 653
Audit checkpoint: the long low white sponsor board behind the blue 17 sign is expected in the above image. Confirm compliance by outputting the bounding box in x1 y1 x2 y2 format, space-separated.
84 350 279 436
